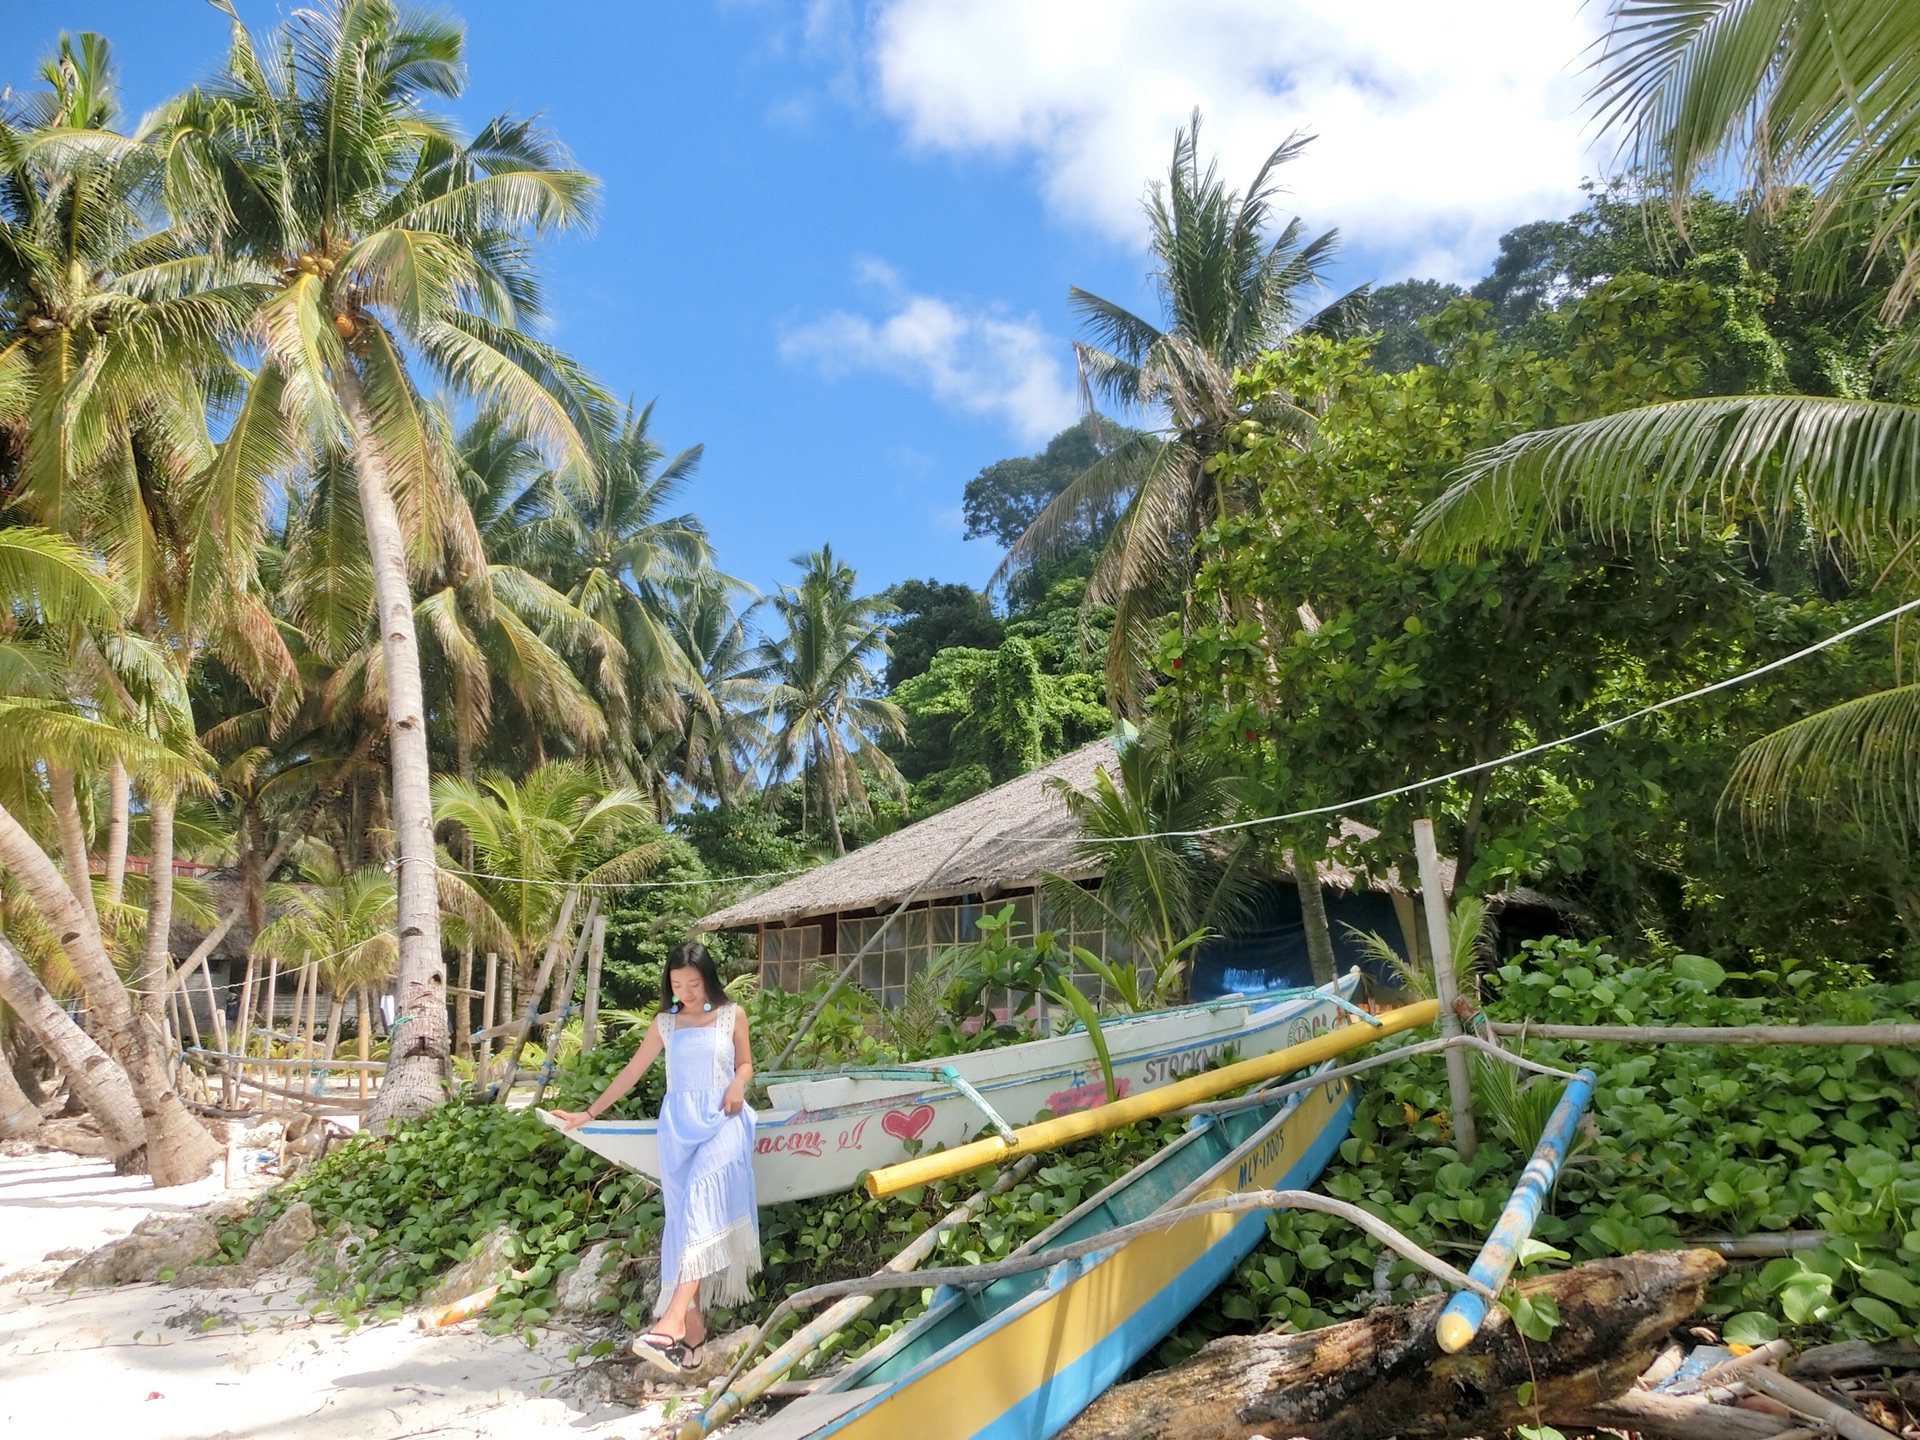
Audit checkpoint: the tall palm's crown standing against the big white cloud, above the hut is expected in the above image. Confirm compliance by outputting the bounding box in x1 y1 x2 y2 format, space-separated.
995 111 1365 705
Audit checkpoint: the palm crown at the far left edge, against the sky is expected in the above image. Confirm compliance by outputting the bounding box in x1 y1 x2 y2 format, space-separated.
0 35 252 549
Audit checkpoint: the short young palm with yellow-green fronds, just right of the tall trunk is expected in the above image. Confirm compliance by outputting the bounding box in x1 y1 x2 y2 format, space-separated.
434 760 660 996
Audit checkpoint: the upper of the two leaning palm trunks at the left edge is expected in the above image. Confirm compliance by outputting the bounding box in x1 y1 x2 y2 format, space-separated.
0 808 221 1188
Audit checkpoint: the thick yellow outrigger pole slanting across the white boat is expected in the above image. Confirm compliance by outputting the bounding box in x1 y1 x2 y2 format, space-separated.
866 1000 1440 1198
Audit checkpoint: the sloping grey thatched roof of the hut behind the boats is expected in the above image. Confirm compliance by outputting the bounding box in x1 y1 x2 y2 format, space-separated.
695 739 1405 929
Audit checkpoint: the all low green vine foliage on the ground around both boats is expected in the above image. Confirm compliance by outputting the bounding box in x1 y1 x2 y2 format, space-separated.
225 941 1920 1363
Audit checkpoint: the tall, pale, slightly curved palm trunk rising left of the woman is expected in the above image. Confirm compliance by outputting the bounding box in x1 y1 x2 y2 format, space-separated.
338 365 449 1125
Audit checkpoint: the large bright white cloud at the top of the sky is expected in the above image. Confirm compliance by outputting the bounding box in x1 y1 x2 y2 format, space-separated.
866 0 1611 278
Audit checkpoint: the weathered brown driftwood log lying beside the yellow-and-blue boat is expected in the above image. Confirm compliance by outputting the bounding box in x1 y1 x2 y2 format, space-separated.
1060 1250 1728 1440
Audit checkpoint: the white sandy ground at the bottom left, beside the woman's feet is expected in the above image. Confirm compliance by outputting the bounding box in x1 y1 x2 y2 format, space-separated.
0 1152 683 1440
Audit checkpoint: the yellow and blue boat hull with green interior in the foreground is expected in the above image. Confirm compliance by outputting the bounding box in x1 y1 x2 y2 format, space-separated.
725 1062 1356 1440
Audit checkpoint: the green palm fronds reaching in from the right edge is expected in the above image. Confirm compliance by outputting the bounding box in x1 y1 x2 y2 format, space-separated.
1413 0 1920 829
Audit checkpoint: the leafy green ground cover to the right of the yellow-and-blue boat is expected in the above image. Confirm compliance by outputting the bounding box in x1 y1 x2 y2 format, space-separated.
1164 941 1920 1357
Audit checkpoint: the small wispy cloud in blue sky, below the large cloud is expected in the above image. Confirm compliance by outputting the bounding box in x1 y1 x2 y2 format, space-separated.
780 261 1075 442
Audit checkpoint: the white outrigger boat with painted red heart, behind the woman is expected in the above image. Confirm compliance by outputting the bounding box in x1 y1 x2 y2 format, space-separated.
540 975 1371 1206
